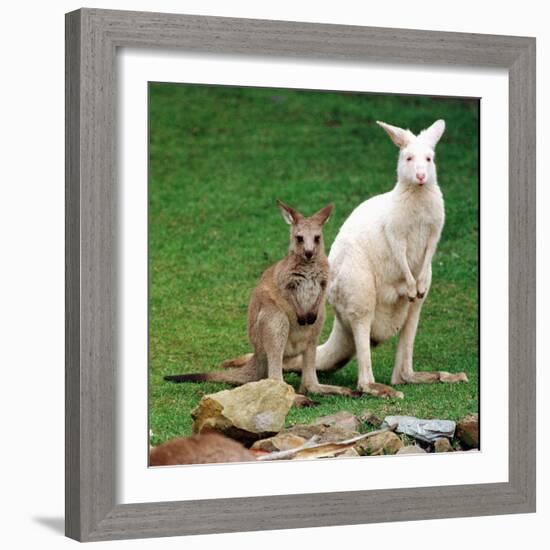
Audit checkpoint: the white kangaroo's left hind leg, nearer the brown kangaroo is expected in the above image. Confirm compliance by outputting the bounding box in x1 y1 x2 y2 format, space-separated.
351 317 403 399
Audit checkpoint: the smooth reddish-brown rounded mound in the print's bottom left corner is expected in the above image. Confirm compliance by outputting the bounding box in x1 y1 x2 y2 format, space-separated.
149 433 256 466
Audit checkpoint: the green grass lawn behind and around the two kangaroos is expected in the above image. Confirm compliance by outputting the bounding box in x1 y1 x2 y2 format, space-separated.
149 84 479 444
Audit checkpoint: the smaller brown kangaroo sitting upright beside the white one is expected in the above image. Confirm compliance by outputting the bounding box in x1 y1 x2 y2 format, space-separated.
165 201 353 406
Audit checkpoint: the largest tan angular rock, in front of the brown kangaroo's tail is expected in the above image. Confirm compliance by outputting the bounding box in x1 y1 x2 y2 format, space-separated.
191 379 295 444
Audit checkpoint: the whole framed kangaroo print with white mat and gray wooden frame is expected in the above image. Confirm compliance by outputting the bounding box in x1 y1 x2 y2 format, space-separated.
66 9 535 540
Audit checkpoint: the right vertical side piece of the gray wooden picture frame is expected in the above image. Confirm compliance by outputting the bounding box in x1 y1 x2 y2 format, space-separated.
508 40 536 510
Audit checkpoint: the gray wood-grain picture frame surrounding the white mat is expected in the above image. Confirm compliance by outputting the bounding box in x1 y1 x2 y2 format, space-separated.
65 9 535 541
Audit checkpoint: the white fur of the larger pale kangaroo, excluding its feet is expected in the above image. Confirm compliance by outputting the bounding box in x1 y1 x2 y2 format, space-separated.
317 120 445 391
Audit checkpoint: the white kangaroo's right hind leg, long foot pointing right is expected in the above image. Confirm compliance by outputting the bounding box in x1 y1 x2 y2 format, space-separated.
391 300 468 384
